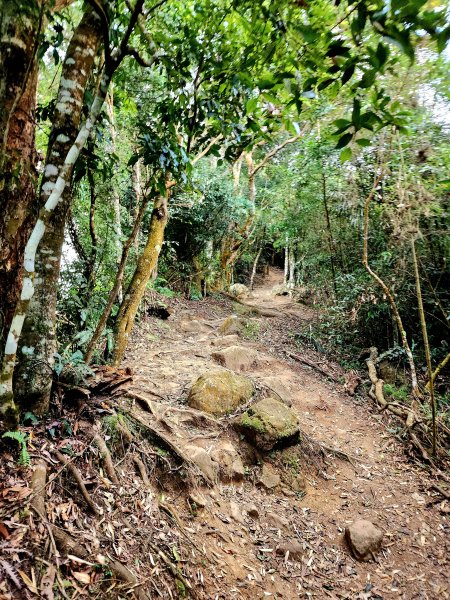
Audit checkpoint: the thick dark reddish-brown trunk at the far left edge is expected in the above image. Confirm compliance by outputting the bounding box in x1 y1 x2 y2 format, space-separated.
0 0 42 361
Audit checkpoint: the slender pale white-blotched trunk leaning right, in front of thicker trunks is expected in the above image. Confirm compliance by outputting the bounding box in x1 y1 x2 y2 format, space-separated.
0 0 144 428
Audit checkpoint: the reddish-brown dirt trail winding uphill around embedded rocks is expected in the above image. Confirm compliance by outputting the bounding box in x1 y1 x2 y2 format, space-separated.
121 270 450 600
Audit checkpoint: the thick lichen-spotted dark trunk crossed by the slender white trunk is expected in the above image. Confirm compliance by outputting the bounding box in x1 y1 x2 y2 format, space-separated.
14 8 102 414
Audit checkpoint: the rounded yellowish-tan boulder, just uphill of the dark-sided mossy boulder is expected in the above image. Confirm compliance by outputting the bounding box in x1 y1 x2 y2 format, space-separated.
188 371 254 416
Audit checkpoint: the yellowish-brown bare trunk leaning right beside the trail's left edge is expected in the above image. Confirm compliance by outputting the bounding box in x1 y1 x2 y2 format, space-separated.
113 192 168 365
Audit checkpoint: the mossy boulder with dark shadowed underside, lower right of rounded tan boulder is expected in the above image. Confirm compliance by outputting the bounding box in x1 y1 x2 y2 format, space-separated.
234 397 300 451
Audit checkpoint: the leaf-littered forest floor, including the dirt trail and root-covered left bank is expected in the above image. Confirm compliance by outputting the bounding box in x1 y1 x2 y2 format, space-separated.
0 271 450 600
